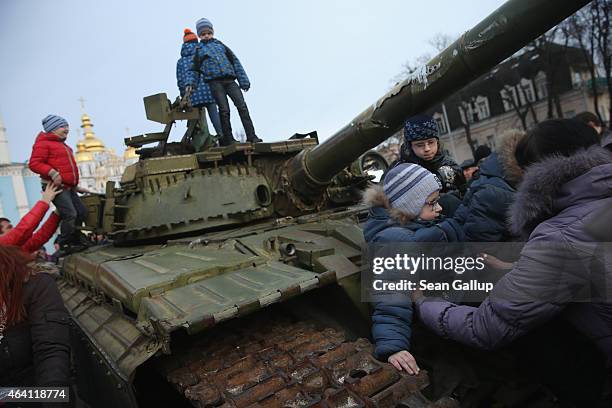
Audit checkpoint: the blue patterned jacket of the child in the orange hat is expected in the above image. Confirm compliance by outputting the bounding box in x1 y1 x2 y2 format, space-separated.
176 41 215 107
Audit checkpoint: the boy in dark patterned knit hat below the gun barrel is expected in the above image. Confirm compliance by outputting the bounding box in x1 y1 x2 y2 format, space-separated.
395 115 466 216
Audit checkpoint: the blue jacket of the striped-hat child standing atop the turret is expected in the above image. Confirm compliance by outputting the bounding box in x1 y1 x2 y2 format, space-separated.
192 38 251 89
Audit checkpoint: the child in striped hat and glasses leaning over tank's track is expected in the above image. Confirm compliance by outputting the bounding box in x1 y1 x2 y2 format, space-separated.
363 163 463 374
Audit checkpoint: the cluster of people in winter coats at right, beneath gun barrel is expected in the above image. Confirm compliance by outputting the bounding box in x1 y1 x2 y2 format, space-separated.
364 113 612 401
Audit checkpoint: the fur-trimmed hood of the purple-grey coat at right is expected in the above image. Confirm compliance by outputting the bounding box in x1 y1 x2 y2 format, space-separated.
510 146 612 236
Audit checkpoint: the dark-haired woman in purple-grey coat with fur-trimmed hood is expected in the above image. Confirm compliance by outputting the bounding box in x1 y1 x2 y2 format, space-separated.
416 120 612 360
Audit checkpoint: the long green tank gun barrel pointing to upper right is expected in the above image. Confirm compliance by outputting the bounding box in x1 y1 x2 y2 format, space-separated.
288 0 589 199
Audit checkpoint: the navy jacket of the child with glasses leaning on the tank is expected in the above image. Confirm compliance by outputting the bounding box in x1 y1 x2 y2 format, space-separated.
363 193 462 361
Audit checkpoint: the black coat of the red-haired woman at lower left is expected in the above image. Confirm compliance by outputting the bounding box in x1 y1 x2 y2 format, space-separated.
0 273 70 390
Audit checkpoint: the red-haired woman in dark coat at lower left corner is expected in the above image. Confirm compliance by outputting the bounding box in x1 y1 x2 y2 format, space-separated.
0 246 70 407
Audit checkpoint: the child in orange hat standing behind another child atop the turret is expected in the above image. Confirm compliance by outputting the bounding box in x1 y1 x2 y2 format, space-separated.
176 28 223 151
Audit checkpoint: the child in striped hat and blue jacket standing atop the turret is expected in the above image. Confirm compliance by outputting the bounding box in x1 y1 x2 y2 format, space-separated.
190 18 262 146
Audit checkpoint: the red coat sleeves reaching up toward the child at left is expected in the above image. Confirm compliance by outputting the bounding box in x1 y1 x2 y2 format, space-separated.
0 201 60 253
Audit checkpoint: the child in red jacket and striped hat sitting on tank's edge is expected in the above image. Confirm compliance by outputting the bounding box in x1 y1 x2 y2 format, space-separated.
30 115 87 249
